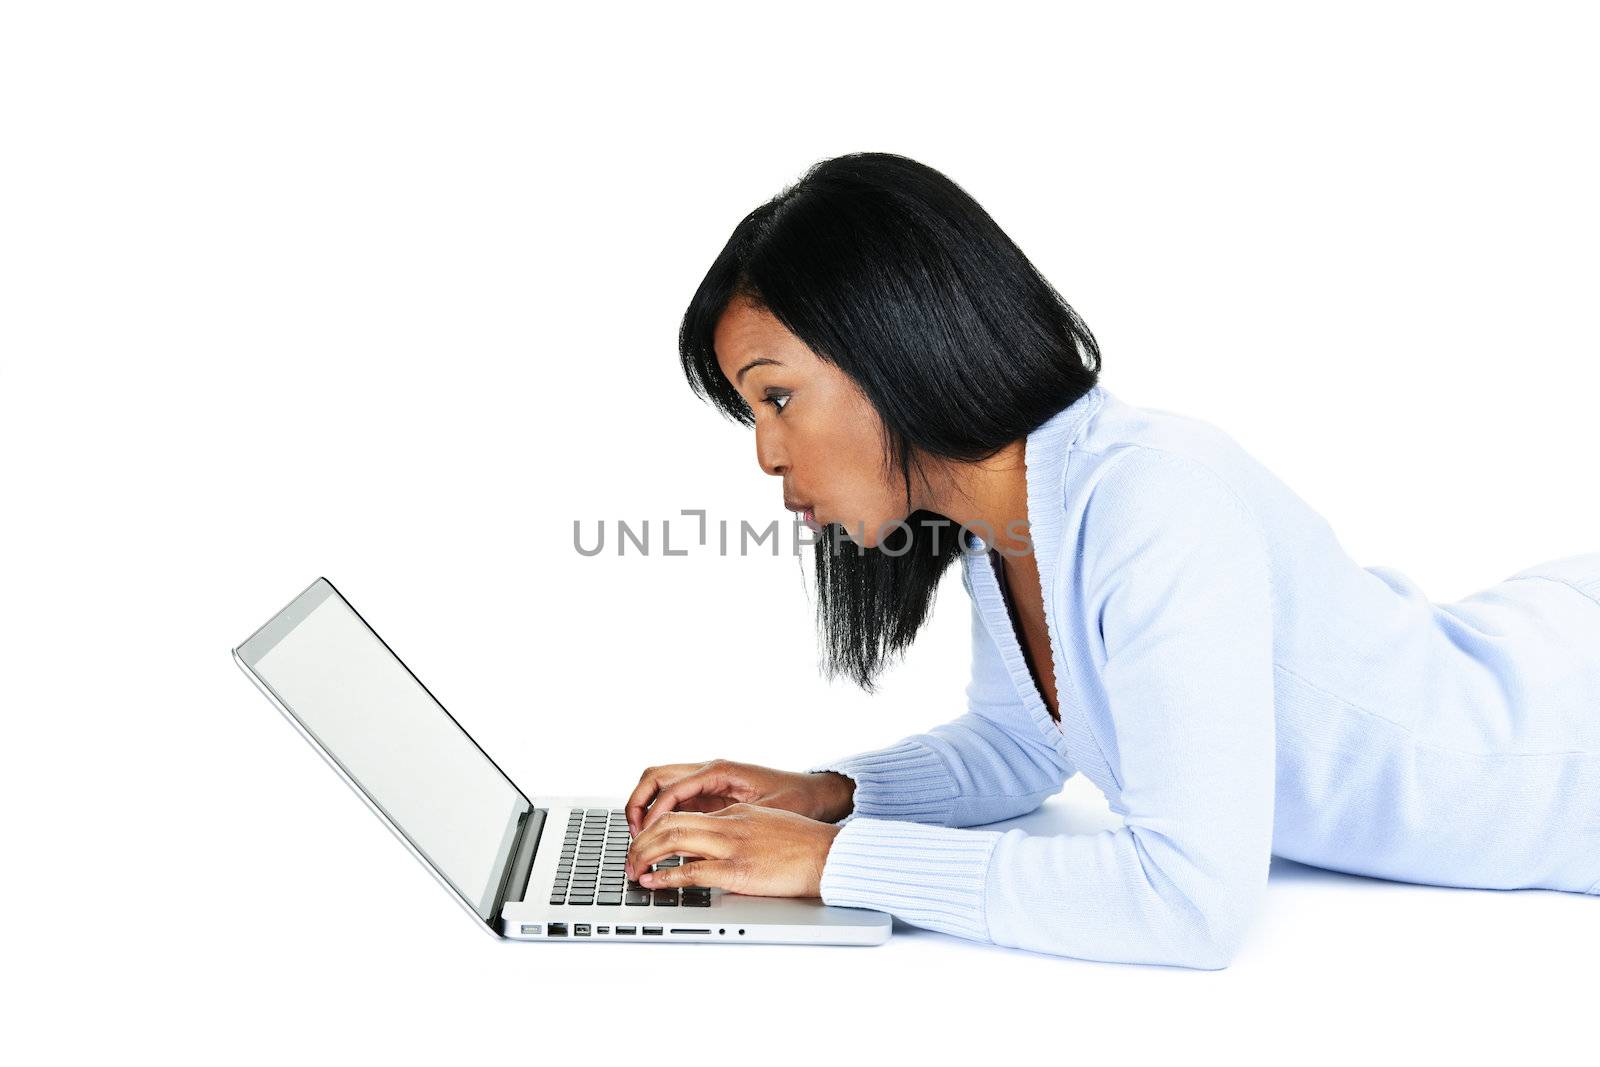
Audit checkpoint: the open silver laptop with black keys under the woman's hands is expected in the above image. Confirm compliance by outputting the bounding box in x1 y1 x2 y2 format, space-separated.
234 577 891 945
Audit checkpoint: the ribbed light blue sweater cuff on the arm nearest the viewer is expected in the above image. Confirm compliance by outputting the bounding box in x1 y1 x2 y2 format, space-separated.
821 819 1002 941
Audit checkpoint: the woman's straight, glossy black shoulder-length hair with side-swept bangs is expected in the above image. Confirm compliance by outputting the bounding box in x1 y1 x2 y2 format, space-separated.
678 152 1099 693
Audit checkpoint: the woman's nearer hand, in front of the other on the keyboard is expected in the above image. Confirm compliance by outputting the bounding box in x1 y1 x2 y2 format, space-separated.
627 803 840 896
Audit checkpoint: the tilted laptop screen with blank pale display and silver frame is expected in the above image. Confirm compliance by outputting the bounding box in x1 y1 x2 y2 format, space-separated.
238 579 530 921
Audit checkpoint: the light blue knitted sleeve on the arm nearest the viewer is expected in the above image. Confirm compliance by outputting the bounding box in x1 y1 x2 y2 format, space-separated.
821 448 1275 969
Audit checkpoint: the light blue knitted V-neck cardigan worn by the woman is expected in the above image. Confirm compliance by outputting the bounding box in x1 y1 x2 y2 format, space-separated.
811 386 1600 969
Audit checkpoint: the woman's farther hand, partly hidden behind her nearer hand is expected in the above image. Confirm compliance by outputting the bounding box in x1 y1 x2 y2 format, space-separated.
627 760 856 837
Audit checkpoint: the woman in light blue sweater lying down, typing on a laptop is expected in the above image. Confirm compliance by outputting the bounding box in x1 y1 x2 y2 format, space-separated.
627 154 1600 969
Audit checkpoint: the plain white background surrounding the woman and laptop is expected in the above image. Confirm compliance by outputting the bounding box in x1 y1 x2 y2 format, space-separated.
0 2 1600 1062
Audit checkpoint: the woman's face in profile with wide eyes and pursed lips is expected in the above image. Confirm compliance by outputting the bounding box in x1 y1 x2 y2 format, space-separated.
712 298 907 549
